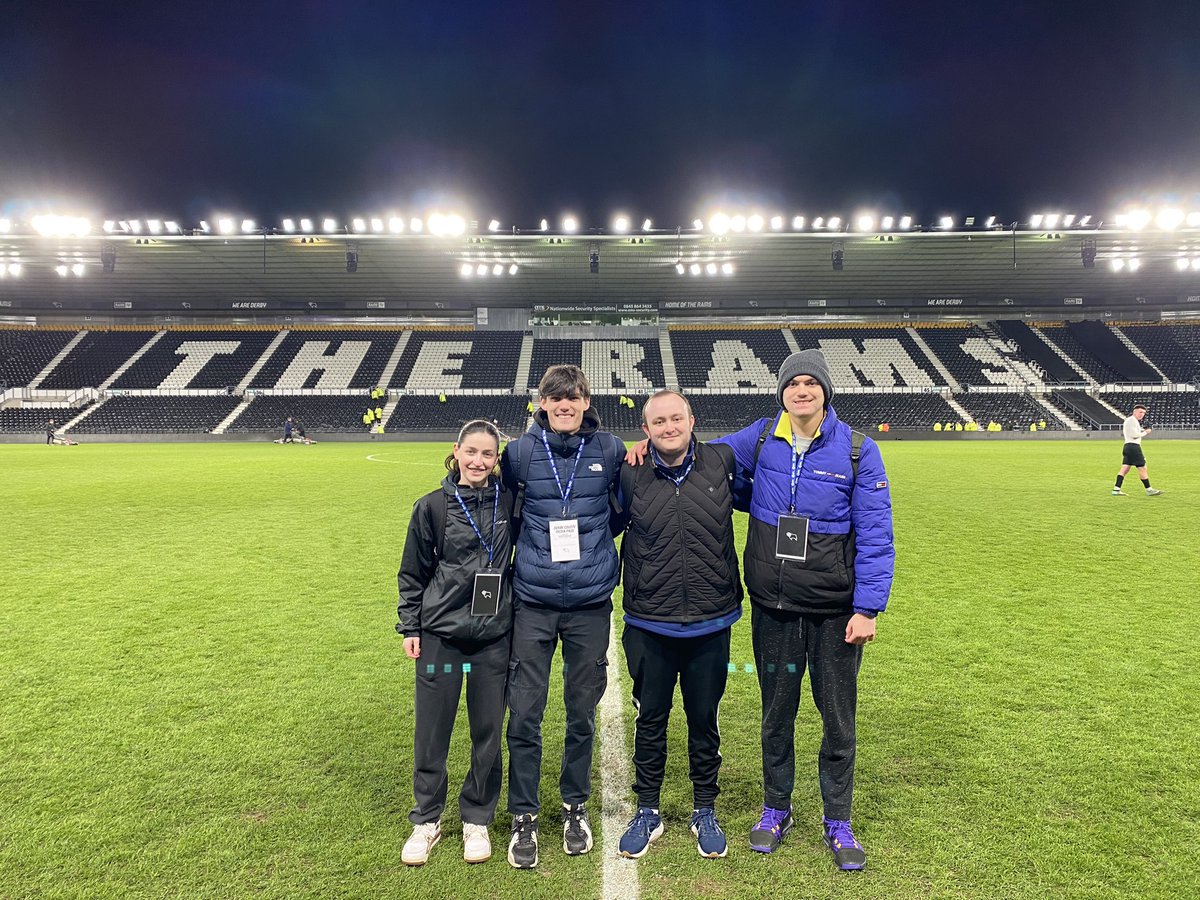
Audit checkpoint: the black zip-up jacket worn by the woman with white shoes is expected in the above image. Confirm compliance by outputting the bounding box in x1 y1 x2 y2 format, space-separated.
396 473 512 641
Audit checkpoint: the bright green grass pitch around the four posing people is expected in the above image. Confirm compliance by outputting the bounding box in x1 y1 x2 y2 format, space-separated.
0 440 1200 900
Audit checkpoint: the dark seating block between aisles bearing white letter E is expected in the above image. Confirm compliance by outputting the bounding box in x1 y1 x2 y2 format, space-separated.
386 331 523 391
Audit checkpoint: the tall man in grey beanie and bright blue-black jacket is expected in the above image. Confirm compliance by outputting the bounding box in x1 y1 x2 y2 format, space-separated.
719 349 895 870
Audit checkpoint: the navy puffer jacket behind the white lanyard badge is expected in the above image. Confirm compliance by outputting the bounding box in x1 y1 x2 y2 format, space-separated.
500 409 625 610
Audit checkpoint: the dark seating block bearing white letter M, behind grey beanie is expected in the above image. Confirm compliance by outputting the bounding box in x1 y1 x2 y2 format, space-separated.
792 325 946 389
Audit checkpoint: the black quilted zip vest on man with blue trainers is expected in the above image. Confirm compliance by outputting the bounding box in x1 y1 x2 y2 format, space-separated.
620 443 742 623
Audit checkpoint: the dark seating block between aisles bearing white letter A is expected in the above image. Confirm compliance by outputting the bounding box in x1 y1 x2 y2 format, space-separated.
670 328 792 391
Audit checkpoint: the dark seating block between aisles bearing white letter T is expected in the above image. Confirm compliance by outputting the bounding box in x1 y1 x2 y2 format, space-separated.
112 329 277 390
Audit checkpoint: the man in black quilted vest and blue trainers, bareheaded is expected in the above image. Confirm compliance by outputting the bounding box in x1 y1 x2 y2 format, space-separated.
618 391 742 859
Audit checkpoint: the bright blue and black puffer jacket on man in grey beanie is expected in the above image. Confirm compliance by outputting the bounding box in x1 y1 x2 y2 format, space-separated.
719 407 895 616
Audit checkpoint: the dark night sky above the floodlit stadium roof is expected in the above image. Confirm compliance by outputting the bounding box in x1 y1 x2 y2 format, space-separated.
0 0 1200 227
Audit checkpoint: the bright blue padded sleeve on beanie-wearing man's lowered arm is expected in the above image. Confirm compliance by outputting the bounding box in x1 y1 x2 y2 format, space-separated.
850 438 896 616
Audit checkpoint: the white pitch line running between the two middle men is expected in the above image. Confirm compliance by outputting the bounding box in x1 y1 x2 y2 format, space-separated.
600 612 640 900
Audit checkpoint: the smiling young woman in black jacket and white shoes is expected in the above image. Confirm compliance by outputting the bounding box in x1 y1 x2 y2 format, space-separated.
396 419 512 865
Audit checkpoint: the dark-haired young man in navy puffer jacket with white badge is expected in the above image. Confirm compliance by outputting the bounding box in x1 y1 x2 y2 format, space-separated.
500 366 625 869
